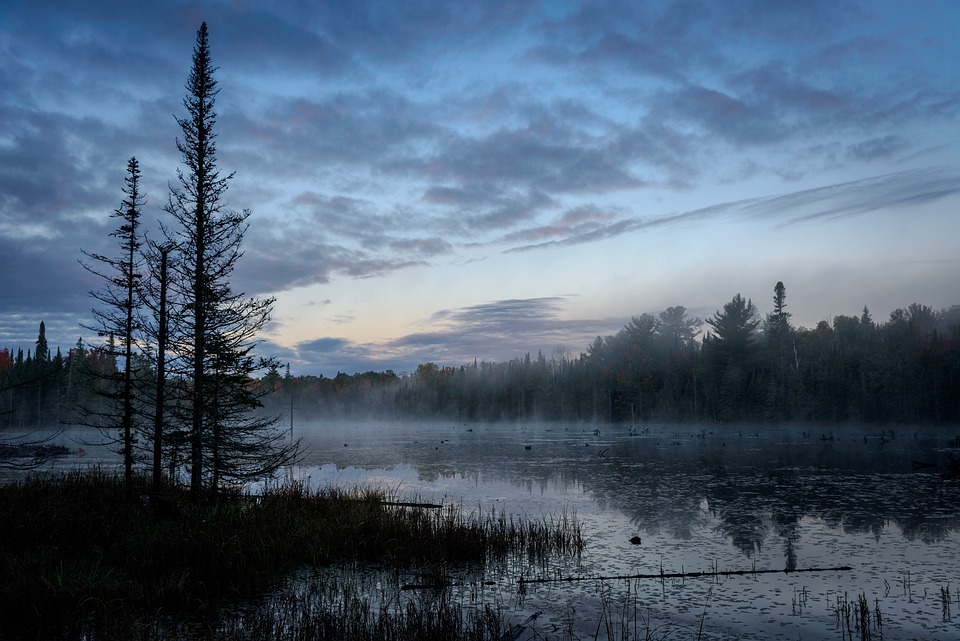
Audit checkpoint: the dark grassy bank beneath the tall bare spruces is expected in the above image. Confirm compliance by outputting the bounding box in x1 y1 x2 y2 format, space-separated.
0 472 583 640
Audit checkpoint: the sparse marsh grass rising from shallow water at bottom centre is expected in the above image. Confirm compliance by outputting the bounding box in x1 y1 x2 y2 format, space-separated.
217 569 688 641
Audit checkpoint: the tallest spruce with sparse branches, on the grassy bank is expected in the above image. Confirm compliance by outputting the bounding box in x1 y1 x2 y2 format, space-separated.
165 23 297 495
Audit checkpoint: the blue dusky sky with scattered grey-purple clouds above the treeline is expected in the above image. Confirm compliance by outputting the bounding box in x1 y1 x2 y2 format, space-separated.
0 0 960 376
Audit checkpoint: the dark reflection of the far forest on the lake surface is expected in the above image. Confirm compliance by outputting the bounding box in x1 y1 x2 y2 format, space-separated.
296 425 960 568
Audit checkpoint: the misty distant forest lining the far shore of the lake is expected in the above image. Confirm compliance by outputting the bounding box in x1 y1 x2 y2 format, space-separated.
7 283 960 428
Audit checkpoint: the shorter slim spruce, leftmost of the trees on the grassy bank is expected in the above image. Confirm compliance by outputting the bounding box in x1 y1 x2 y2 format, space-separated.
81 158 146 489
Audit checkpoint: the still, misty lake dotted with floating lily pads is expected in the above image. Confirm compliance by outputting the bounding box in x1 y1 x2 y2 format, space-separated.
7 423 960 640
